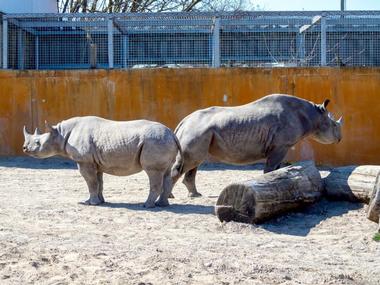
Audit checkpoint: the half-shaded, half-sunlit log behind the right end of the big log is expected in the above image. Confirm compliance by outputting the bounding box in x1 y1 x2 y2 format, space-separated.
323 165 380 204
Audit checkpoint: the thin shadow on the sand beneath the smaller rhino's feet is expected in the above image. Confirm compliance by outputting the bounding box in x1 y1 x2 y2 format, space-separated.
98 202 214 215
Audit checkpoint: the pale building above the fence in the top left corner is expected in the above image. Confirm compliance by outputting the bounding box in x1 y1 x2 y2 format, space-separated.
0 0 57 13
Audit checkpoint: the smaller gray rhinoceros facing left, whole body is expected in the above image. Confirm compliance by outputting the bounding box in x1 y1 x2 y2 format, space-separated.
23 116 181 208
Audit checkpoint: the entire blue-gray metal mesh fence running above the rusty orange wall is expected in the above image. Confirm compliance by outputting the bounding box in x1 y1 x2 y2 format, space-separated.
0 11 380 69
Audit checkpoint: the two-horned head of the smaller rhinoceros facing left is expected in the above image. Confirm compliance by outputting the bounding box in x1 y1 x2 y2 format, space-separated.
23 121 61 158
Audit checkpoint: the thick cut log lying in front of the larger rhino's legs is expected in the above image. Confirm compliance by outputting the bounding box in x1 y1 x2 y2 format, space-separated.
215 161 323 223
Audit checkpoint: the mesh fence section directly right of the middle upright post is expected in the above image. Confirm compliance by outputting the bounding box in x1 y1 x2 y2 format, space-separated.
221 14 310 66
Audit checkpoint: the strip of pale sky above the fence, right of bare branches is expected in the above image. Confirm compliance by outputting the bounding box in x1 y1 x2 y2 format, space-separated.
250 0 380 11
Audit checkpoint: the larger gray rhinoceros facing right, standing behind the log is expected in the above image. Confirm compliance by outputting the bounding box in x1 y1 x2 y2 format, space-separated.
172 94 342 197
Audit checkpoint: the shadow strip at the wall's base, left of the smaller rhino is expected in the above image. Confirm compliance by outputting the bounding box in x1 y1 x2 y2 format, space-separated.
0 156 77 169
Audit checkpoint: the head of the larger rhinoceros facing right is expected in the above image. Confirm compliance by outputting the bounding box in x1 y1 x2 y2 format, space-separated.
312 99 343 144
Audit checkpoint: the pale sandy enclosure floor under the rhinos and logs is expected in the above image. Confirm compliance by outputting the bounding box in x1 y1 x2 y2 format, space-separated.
0 157 380 285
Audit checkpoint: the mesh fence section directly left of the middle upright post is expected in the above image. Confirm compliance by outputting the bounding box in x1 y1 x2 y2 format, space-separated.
113 13 212 67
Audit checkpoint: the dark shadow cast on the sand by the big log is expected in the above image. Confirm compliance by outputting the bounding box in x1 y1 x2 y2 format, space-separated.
258 198 363 236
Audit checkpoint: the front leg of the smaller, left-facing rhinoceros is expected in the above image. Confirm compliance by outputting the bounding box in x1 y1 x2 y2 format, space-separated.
78 163 104 205
